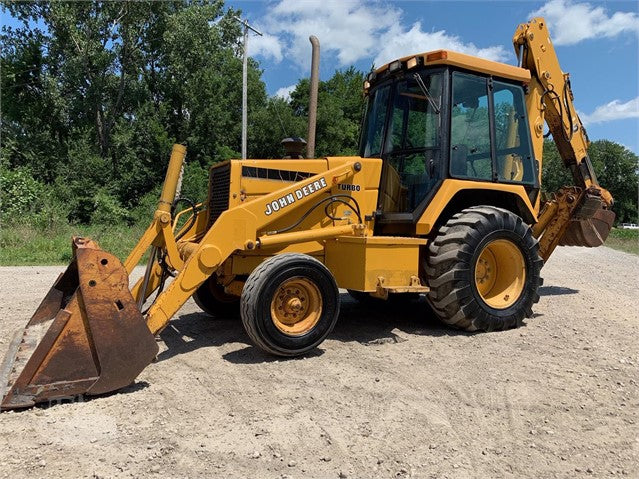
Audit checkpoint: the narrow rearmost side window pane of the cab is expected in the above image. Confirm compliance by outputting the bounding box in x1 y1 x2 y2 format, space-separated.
493 81 535 183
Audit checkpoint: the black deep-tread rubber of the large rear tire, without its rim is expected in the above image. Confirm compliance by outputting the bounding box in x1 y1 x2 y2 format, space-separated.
426 206 544 331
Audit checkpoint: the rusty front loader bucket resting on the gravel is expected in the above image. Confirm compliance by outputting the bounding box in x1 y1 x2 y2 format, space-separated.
0 238 158 410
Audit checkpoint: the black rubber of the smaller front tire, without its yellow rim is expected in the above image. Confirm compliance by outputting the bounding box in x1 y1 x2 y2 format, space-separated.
240 253 340 356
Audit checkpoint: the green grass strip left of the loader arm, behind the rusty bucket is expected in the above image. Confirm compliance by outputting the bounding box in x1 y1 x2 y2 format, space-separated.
0 225 146 266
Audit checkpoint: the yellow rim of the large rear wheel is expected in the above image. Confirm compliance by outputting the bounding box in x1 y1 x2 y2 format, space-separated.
475 239 526 309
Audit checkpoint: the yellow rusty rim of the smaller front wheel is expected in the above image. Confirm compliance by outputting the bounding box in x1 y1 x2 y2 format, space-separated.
271 277 322 336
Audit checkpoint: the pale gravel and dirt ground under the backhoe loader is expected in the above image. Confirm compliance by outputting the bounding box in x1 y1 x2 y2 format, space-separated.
0 248 639 479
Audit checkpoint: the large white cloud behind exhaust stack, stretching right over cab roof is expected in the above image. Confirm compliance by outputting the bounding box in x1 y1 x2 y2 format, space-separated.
255 0 507 70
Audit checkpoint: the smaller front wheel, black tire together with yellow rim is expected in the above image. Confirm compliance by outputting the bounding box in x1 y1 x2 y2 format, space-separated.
240 253 340 356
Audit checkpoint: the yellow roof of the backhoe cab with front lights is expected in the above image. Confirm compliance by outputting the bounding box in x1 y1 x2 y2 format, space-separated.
375 50 530 83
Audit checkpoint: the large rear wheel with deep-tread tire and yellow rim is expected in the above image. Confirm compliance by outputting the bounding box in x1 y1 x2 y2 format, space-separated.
426 206 544 331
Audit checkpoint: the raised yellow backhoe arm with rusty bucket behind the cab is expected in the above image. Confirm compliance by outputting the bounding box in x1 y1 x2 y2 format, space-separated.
513 18 615 260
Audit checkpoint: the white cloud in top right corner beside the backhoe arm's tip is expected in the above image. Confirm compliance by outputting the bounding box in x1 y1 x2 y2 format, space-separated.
529 0 639 45
